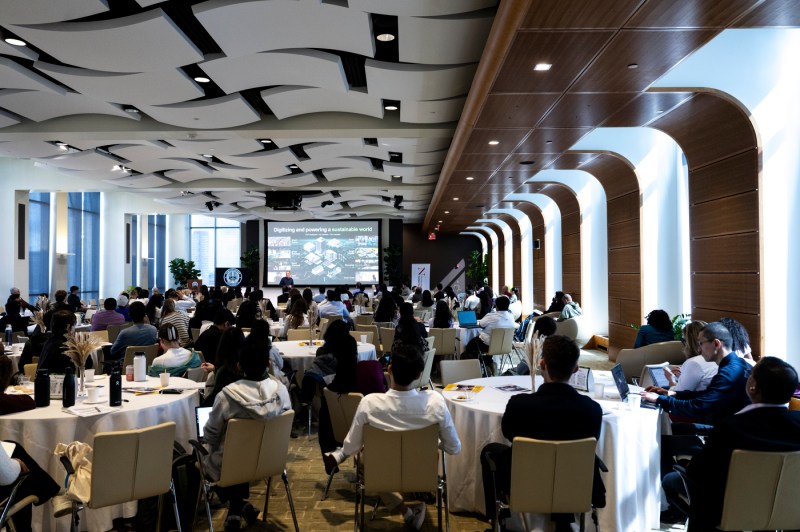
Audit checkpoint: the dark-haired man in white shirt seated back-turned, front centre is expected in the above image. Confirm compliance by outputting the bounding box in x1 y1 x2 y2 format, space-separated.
323 344 461 530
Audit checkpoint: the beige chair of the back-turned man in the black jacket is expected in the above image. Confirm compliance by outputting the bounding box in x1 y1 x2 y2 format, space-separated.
489 436 597 532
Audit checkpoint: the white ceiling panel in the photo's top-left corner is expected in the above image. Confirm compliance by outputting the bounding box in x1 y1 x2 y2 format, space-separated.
0 0 108 24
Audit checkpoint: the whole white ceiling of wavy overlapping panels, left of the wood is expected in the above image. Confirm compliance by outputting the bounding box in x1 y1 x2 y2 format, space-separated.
0 0 497 222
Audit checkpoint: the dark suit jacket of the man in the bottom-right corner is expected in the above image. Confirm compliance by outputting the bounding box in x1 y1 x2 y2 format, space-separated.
689 407 800 531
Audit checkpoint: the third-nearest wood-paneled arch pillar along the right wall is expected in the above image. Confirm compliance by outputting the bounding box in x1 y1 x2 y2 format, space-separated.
531 182 581 302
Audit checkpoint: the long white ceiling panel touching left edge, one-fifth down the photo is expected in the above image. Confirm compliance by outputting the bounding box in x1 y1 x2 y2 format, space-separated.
0 90 139 122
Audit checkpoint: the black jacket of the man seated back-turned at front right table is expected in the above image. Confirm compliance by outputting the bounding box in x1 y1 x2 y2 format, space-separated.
501 382 605 508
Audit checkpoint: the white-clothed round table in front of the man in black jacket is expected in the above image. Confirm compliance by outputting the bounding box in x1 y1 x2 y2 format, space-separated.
442 371 661 532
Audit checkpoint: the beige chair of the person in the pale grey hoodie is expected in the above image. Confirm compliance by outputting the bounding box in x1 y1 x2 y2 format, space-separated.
189 410 300 532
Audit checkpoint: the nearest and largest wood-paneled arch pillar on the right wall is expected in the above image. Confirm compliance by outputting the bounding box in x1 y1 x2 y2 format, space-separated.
650 92 764 355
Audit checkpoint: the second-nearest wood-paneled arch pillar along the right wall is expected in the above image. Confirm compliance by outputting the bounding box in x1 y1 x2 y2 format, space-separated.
581 153 643 360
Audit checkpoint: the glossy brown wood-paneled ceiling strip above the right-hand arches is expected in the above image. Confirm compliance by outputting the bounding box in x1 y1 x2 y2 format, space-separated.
423 0 800 232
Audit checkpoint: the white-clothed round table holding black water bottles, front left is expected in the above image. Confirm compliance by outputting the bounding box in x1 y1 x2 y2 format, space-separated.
0 376 203 531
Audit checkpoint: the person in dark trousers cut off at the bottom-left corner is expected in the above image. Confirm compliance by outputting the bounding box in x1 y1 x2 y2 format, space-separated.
0 442 61 532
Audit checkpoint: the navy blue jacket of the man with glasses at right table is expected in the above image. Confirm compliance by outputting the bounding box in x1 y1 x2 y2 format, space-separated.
657 353 752 424
